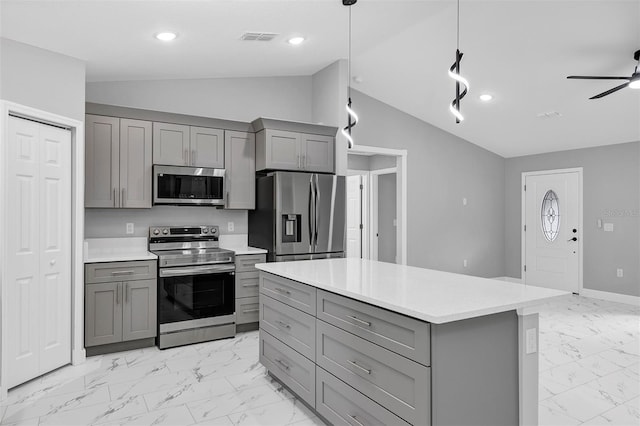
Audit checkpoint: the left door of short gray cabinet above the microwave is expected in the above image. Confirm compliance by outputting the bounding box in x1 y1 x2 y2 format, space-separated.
153 123 190 166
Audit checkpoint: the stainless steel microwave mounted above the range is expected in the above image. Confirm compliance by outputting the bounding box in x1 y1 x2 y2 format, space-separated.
153 165 226 207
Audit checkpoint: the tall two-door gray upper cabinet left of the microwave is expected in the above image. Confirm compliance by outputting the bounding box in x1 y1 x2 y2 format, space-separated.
85 115 152 208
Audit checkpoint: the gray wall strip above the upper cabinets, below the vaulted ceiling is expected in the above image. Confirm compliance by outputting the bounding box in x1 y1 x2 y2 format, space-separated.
87 77 311 122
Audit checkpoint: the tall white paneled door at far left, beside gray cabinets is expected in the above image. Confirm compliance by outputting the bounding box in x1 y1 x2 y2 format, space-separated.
3 117 71 388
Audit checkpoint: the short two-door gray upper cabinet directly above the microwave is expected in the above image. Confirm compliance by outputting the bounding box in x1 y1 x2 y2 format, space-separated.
153 122 224 168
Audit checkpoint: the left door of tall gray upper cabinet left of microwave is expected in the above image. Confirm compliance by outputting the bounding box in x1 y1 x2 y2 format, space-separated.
84 114 120 208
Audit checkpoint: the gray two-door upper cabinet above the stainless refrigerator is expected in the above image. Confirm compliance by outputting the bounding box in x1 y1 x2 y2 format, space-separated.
256 129 335 173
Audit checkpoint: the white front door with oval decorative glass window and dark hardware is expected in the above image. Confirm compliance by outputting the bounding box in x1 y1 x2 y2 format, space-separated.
523 170 582 293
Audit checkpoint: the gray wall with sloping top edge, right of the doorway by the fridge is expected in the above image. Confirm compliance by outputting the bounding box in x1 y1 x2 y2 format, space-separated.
352 90 505 277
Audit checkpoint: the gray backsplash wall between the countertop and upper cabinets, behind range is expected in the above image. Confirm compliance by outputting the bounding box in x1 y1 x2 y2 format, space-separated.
84 206 247 238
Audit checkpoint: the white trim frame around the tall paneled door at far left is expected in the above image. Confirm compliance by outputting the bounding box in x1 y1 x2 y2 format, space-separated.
0 100 86 400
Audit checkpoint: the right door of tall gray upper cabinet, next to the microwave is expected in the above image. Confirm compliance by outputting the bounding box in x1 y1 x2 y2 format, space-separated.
120 118 152 208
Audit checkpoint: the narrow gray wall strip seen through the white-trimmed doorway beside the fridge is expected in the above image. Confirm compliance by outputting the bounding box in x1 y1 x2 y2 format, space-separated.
378 173 397 263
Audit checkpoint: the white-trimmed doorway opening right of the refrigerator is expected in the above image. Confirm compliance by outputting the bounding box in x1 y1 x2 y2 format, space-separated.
347 146 407 265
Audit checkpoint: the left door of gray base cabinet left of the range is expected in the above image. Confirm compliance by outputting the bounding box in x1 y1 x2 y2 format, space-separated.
84 282 122 346
